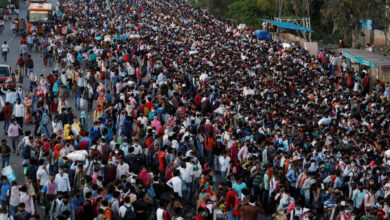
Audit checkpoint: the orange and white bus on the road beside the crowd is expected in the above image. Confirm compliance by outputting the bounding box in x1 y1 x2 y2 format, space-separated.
27 3 53 34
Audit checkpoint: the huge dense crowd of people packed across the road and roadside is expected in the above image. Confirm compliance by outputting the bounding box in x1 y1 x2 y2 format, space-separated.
0 0 390 220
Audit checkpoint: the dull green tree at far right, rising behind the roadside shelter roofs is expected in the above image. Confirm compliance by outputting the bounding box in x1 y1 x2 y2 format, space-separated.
323 0 386 48
